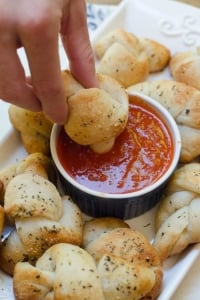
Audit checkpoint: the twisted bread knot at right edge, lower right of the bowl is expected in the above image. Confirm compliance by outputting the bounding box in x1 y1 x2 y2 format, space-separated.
154 163 200 260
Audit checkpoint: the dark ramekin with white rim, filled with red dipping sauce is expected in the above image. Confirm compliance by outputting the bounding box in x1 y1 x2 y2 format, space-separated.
50 92 181 219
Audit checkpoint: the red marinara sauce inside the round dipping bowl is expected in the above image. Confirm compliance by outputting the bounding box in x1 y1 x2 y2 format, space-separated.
57 96 174 194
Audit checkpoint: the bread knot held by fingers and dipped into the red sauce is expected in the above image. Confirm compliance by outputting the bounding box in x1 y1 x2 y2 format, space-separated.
63 71 128 153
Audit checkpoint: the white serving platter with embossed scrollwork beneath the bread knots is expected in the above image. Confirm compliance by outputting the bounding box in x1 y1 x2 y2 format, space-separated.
0 0 200 300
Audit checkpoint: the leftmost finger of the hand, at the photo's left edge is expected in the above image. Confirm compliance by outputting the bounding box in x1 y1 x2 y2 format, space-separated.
0 30 41 111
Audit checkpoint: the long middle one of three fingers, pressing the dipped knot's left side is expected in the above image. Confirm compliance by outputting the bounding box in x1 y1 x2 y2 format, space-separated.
18 8 67 123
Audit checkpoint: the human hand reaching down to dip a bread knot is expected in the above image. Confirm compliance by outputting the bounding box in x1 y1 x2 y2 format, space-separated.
0 0 97 123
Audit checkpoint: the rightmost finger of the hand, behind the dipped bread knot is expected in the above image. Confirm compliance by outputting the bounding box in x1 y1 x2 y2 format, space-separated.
61 0 98 87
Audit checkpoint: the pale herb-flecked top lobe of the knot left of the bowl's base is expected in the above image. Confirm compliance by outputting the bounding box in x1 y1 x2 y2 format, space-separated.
4 172 62 220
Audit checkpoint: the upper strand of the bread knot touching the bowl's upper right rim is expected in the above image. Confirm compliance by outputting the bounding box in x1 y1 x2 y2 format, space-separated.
128 79 200 129
